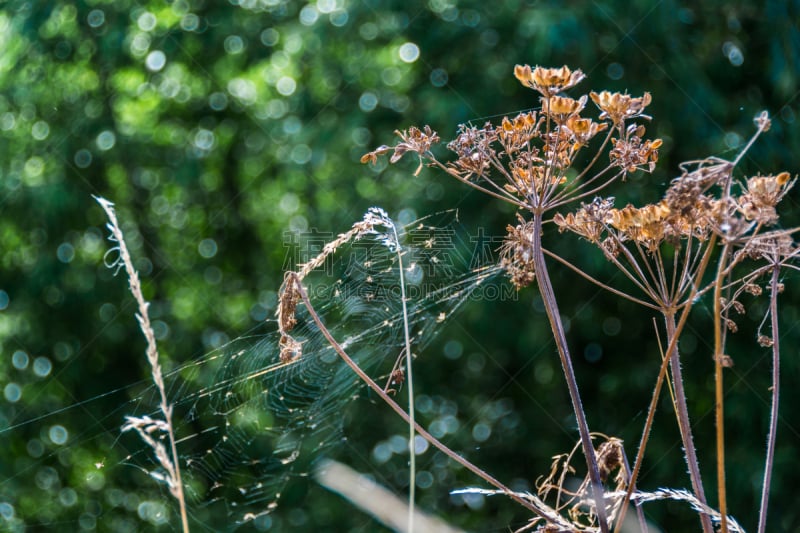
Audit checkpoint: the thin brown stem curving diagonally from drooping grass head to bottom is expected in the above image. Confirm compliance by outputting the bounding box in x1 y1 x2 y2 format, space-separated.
287 272 544 516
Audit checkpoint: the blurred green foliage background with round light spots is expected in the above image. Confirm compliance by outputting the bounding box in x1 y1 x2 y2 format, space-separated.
0 0 800 531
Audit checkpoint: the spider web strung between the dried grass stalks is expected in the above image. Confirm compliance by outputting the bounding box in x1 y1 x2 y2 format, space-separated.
122 212 510 528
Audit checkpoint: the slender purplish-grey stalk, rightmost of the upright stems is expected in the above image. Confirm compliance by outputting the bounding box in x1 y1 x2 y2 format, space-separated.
758 263 781 533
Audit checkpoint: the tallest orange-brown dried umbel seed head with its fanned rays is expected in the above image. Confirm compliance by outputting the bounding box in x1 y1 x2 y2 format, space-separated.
362 65 661 218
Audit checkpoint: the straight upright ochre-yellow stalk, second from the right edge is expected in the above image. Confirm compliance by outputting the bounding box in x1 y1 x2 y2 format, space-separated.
714 243 730 533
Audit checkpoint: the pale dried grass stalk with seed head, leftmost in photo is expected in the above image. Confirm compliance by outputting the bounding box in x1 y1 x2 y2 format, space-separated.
94 196 189 533
